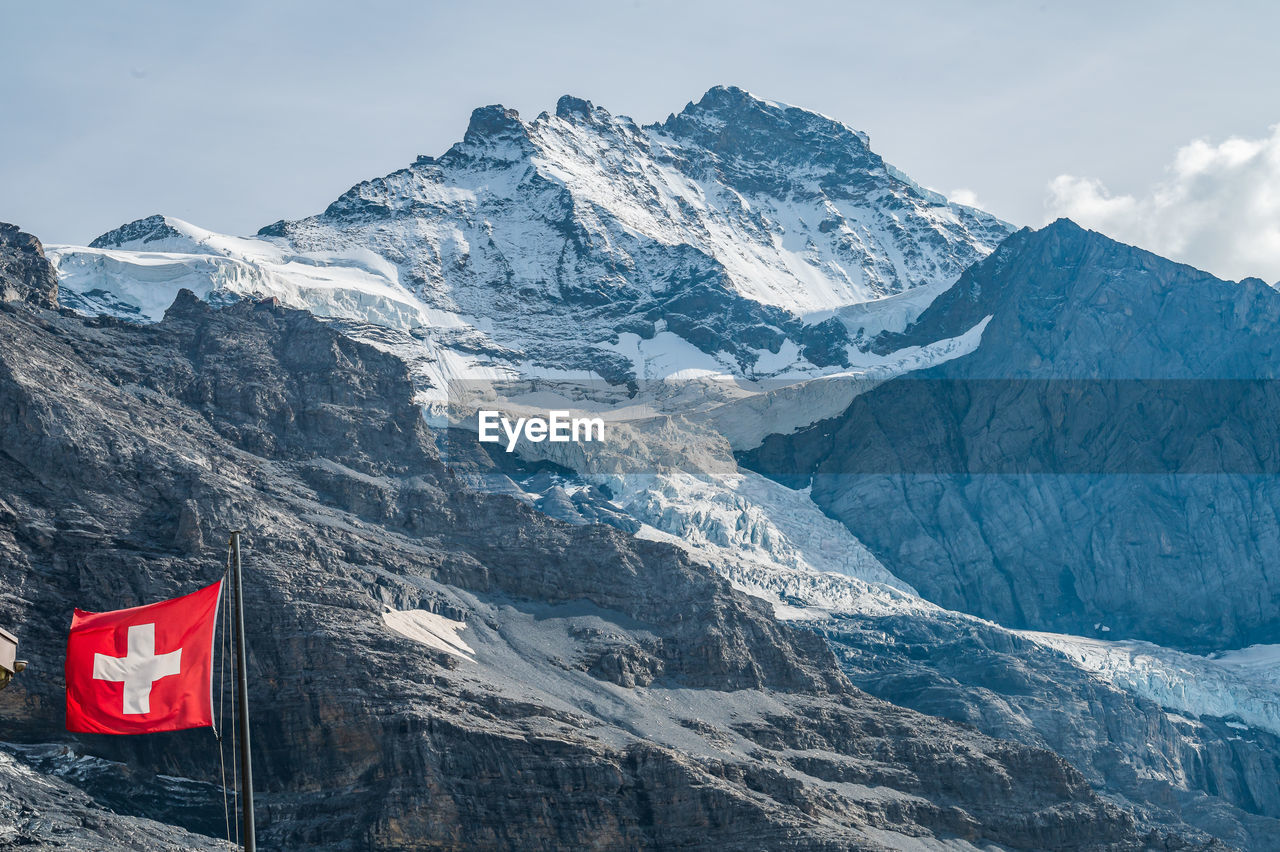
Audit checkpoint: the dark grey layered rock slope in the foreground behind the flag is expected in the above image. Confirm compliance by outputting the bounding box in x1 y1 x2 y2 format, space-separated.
0 245 1210 849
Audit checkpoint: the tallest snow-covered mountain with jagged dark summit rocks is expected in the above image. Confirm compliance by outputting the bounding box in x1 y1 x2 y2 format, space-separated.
51 87 1012 381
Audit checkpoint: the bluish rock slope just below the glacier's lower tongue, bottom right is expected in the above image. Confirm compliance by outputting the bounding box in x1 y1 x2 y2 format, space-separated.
822 613 1280 852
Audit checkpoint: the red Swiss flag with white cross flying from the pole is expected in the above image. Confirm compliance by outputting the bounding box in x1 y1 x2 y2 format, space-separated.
67 581 223 734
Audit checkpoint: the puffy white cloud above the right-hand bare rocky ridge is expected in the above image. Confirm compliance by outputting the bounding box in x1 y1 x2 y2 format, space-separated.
1046 124 1280 281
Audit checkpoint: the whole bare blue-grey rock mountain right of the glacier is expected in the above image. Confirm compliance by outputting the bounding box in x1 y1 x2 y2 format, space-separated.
744 220 1280 651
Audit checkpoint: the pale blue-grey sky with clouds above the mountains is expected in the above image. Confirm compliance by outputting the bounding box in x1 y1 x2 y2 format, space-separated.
0 0 1280 281
